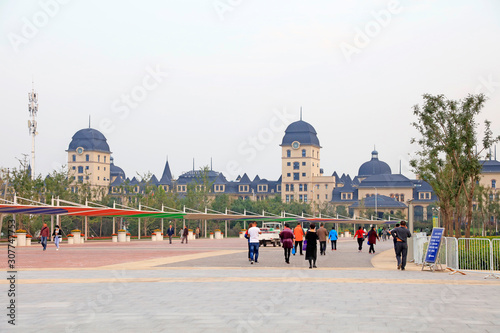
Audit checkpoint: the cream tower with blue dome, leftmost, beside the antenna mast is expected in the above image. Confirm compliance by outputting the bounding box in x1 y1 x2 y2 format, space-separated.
66 127 112 196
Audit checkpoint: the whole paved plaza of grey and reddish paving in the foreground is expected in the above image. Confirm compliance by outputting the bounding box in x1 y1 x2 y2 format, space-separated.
0 239 500 332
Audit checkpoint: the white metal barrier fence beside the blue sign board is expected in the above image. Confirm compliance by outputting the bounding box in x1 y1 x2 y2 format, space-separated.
414 237 500 278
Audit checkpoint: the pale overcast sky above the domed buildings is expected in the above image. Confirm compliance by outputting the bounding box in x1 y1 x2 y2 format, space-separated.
0 0 500 180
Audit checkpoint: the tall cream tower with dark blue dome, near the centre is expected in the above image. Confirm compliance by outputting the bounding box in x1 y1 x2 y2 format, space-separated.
281 119 335 204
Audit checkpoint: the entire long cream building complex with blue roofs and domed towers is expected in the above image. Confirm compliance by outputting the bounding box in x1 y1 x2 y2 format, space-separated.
67 120 500 221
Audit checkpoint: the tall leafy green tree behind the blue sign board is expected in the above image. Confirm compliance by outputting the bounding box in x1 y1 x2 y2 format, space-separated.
410 94 499 237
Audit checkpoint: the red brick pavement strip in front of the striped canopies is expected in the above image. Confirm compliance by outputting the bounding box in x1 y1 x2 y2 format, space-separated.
0 239 247 269
